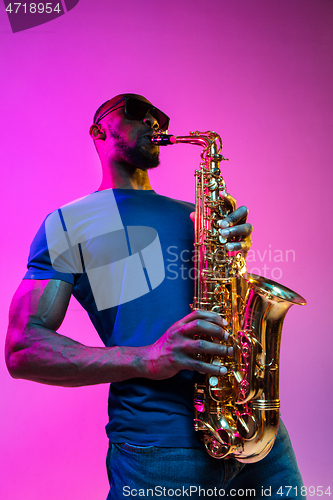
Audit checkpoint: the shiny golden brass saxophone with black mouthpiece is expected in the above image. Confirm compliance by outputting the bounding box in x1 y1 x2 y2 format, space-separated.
152 131 306 463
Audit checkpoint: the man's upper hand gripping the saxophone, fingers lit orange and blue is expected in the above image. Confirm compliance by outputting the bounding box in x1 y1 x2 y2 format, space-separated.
190 195 253 257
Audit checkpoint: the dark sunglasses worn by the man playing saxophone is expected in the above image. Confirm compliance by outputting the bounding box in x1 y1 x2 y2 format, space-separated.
95 97 170 132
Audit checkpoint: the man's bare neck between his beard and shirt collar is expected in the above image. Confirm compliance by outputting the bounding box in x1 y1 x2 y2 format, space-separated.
98 162 152 191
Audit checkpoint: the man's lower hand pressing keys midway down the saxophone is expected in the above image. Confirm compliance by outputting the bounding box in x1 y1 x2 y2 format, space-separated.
142 310 233 380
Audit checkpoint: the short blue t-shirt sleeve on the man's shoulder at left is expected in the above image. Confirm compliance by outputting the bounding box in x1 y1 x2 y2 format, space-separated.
23 210 82 285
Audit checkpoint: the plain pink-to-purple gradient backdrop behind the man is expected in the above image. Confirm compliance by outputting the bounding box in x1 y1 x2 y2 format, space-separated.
0 0 333 500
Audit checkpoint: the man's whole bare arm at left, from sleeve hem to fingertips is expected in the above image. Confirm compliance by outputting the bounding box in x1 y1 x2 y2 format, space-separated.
6 280 230 387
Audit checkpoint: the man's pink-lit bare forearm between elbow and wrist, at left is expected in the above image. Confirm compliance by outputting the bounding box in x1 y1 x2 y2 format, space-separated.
6 325 147 387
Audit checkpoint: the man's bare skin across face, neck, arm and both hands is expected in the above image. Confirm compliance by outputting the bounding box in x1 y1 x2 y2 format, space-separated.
5 96 252 387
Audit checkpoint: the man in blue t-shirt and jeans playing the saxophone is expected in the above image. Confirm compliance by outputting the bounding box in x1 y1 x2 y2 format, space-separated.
6 94 301 499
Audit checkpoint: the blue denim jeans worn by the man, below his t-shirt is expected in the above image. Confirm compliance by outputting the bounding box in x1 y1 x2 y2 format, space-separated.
107 421 305 500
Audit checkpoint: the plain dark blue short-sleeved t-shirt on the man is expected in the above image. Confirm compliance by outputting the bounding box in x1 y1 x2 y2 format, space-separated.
24 189 201 447
